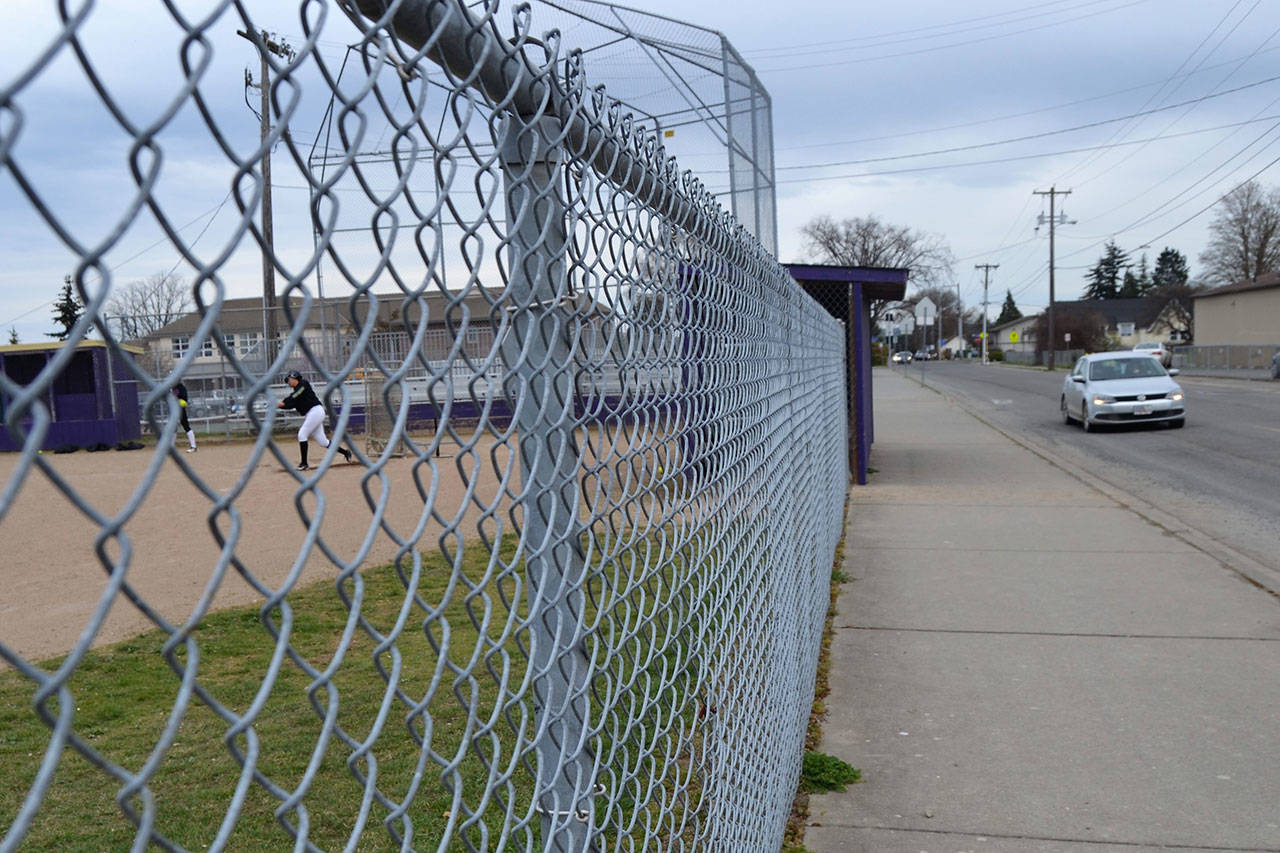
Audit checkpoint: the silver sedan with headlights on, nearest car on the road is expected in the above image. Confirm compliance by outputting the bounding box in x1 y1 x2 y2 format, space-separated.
1061 351 1187 432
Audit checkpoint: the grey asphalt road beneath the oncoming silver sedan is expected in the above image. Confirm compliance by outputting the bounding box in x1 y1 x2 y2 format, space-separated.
892 361 1280 593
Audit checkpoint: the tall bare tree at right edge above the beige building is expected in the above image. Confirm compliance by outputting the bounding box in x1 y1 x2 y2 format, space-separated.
1199 181 1280 286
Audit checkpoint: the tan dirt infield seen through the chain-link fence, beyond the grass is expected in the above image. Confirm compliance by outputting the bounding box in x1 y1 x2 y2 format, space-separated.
0 442 518 666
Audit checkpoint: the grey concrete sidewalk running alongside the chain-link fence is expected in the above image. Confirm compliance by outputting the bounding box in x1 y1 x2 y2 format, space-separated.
805 370 1280 853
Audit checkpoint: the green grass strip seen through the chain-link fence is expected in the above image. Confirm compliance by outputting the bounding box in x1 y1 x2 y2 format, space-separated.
0 532 700 850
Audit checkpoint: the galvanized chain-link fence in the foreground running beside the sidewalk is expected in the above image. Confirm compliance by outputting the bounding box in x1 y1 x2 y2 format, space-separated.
0 0 849 852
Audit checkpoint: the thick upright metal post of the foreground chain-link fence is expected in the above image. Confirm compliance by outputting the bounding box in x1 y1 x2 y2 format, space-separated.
502 117 595 852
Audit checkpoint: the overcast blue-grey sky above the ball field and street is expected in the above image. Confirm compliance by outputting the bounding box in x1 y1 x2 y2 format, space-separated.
0 0 1280 342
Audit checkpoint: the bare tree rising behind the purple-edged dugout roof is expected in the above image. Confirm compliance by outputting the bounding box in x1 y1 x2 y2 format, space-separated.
800 216 955 289
